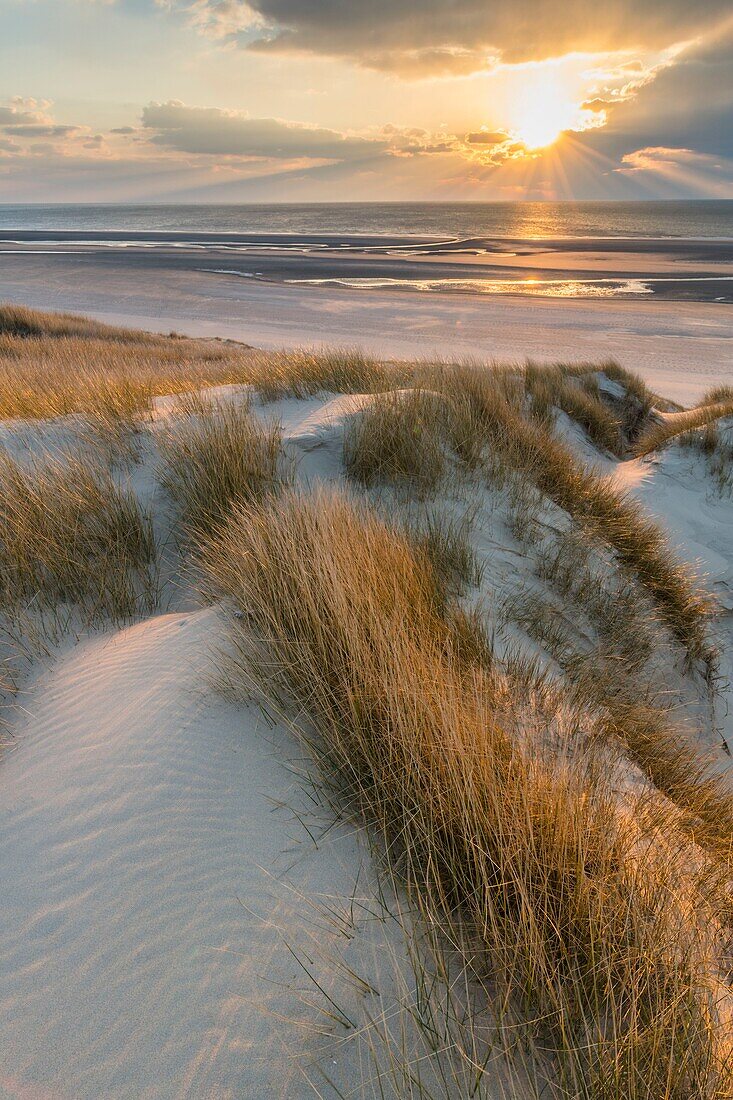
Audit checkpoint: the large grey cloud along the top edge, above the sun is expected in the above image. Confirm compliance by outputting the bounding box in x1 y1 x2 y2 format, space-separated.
158 0 730 76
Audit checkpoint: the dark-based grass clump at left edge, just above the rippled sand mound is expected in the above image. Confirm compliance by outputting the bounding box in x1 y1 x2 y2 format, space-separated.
0 444 157 623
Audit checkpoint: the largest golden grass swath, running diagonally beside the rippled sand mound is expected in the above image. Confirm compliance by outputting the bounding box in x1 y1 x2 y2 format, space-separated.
204 494 733 1100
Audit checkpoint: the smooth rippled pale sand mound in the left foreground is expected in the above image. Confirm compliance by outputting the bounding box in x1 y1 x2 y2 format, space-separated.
0 609 405 1100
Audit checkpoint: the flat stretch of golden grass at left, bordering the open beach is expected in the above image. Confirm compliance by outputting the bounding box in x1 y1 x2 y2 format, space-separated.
0 306 413 426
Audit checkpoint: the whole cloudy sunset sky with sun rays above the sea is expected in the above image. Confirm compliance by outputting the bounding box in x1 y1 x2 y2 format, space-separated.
0 0 733 202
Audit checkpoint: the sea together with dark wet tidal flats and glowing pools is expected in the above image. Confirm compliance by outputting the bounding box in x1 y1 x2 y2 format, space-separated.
0 200 733 305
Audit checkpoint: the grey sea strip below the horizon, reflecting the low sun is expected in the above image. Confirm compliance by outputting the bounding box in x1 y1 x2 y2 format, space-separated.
0 200 733 241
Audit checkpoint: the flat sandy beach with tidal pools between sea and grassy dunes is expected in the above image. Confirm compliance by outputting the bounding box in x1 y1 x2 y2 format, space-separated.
0 230 733 403
